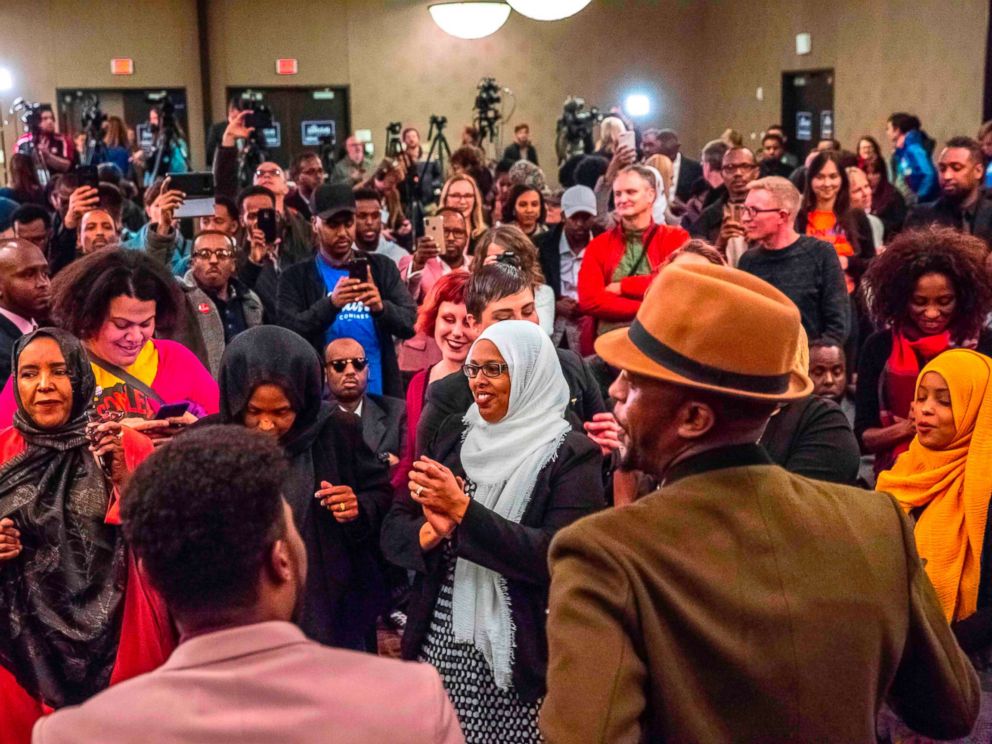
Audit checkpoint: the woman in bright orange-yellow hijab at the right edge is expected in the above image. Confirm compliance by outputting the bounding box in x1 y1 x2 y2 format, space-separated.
876 349 992 742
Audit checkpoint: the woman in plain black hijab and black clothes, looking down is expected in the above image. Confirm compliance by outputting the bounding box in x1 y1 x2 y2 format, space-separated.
219 326 392 653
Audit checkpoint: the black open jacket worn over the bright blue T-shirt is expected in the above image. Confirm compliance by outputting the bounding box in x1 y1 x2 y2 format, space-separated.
276 253 417 398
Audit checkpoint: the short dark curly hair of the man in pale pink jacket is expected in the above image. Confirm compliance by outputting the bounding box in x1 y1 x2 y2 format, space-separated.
121 426 288 612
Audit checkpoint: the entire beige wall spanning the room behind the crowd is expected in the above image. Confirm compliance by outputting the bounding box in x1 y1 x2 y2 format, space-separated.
0 0 988 175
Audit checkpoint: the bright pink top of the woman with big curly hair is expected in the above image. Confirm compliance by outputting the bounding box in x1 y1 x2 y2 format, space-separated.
0 338 220 430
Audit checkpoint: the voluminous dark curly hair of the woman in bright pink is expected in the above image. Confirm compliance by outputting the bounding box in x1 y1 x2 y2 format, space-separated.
52 249 184 340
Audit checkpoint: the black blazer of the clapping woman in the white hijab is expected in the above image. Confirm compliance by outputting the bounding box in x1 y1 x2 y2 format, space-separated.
382 431 606 702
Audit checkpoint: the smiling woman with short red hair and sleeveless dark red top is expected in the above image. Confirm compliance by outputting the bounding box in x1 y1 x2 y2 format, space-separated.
393 271 477 488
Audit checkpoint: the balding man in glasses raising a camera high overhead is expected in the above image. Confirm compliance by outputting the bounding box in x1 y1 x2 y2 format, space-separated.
213 110 313 264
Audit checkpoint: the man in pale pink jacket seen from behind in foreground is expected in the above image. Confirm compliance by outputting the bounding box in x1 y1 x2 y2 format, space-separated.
33 426 464 744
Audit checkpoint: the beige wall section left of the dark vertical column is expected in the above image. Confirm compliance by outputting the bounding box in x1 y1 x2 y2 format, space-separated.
0 0 203 170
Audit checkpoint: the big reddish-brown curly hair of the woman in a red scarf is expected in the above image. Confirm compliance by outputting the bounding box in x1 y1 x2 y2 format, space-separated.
862 227 992 343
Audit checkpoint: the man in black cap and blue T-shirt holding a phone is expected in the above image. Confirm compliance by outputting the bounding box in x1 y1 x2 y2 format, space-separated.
278 184 417 398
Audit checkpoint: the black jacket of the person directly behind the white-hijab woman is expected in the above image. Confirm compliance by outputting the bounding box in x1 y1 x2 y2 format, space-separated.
414 349 607 456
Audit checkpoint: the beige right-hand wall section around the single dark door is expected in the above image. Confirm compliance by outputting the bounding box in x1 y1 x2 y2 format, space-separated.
693 0 989 152
